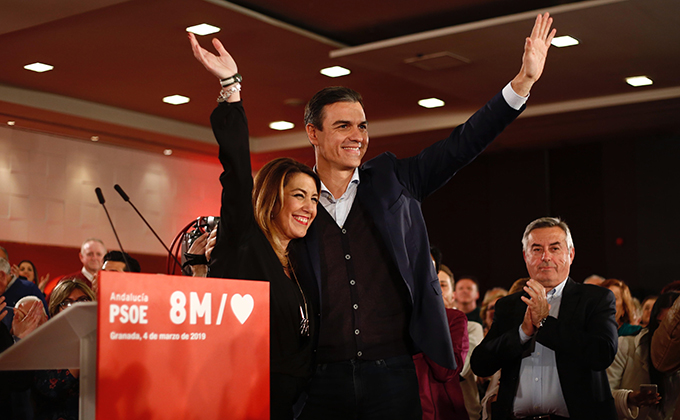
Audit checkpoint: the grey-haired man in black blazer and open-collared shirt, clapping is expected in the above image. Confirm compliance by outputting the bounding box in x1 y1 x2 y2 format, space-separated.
471 217 617 420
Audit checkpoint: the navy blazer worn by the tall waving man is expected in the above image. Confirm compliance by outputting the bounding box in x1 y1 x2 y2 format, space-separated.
292 89 524 369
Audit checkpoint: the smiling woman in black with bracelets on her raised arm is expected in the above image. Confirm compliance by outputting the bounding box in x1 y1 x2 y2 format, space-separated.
189 34 321 419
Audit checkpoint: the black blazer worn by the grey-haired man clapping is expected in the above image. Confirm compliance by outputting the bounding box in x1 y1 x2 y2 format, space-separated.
470 278 618 420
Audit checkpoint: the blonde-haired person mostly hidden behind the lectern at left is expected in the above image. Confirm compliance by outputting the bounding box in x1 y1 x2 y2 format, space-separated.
33 278 95 420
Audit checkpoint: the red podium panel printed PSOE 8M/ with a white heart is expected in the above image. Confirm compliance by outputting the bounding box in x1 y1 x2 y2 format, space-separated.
96 272 269 420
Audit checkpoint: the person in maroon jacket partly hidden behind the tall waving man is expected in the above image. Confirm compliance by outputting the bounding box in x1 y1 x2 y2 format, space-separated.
413 264 469 420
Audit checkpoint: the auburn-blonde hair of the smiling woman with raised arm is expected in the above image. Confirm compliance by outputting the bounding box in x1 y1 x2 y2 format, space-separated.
253 158 321 267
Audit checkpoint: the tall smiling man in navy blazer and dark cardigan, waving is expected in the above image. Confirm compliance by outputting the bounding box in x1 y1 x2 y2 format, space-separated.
292 13 555 419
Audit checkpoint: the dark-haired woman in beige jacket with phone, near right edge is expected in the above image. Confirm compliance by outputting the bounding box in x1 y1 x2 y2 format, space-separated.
607 292 680 420
